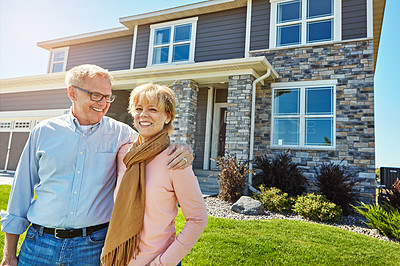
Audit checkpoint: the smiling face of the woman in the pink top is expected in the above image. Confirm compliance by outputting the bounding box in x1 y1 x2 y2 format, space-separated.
132 101 171 141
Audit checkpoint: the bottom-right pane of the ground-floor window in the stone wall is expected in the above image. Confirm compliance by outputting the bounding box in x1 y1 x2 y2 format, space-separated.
305 118 333 146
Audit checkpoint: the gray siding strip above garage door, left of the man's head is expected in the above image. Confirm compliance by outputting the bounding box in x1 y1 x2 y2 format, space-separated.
0 89 71 111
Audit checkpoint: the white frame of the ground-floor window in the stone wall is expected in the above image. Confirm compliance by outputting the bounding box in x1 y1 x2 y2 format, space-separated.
270 80 337 150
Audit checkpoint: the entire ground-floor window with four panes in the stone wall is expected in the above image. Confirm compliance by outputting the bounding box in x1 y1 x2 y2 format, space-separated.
271 81 336 148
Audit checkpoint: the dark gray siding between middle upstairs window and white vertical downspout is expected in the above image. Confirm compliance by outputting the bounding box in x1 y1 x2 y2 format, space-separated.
195 8 246 62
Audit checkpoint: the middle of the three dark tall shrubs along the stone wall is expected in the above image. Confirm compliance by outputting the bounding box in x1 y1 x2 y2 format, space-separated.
256 153 306 196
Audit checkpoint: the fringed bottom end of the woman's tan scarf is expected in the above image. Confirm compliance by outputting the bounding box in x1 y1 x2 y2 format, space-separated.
101 235 140 266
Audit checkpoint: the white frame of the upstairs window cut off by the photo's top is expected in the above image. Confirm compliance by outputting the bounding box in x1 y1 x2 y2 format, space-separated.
269 0 342 49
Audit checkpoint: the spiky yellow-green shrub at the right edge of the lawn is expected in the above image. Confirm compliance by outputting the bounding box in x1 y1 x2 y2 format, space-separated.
353 203 400 240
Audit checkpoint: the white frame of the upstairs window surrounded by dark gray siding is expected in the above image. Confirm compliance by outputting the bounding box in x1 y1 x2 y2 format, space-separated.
147 17 198 67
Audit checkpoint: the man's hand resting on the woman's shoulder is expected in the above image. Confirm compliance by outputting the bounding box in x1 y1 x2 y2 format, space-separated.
167 144 193 170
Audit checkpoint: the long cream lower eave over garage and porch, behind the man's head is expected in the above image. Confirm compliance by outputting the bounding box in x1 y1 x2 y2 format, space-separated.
0 56 279 93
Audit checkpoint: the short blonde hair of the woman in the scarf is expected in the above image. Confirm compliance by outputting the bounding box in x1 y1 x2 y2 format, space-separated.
128 83 176 132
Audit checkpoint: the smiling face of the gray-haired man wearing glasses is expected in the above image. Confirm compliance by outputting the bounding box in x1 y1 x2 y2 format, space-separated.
68 77 112 126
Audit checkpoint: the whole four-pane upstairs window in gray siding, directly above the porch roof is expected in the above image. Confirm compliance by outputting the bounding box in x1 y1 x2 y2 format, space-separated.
147 17 197 66
